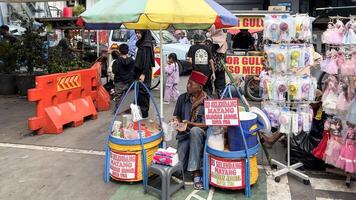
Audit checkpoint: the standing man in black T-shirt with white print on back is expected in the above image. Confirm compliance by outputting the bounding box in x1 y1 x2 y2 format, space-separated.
187 34 216 95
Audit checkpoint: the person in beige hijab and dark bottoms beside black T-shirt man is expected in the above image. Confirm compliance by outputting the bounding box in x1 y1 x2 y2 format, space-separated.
207 25 228 96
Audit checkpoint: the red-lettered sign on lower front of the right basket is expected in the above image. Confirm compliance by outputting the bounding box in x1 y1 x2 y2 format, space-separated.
210 156 245 189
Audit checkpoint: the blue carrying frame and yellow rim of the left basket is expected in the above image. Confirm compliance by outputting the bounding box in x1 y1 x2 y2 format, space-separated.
104 81 163 187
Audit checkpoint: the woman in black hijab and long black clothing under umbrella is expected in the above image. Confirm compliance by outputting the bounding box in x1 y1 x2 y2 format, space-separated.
135 30 155 118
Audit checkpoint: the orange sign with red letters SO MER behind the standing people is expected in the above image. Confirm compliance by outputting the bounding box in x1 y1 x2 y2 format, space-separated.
226 55 263 75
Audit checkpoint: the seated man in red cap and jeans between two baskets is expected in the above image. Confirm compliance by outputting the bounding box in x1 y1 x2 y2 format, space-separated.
172 71 208 190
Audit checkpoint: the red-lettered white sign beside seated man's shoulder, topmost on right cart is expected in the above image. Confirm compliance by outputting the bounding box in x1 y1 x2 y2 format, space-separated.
204 99 240 126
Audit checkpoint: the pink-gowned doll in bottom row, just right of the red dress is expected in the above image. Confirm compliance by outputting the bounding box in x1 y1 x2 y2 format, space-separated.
324 119 342 166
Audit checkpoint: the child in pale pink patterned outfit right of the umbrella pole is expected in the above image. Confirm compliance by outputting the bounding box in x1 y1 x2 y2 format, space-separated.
164 53 179 104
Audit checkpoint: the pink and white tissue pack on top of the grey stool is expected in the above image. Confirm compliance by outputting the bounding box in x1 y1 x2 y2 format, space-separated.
153 147 179 166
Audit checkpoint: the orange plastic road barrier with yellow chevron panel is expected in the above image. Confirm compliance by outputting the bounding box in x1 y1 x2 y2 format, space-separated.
28 63 110 134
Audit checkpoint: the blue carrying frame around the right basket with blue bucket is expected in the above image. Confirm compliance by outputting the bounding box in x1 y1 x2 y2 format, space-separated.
203 84 259 197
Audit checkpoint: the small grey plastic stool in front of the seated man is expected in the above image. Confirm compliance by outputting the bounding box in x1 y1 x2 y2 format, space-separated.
145 162 185 200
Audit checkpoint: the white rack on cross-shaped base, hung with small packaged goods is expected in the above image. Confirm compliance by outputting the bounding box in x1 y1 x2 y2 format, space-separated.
260 14 317 184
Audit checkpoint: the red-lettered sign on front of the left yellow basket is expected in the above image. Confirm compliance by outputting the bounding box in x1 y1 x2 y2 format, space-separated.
110 151 138 180
